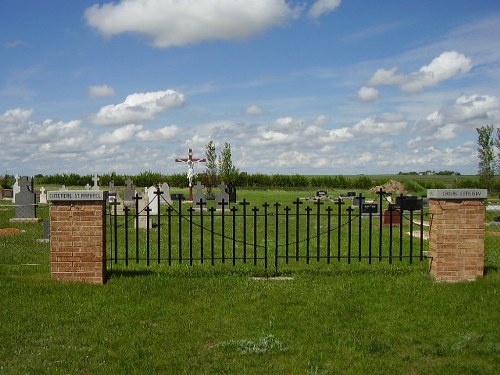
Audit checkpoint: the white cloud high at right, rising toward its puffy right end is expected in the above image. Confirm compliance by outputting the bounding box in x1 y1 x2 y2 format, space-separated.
368 51 472 94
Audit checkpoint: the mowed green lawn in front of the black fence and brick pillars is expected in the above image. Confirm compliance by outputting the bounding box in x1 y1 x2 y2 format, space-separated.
0 191 500 374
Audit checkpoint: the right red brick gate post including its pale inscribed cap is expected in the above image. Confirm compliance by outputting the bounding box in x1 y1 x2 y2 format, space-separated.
427 189 488 282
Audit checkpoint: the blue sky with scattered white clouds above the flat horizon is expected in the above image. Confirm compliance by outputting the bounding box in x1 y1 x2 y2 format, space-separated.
0 0 500 175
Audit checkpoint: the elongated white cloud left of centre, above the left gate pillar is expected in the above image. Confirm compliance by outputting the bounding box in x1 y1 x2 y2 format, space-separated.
90 90 185 125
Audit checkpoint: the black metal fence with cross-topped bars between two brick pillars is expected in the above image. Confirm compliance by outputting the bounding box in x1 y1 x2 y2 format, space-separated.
107 189 427 273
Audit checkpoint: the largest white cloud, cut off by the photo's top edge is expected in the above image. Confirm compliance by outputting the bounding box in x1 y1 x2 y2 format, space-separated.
85 0 296 48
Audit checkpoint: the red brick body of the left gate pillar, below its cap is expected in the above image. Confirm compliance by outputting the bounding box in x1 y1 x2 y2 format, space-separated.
50 200 106 284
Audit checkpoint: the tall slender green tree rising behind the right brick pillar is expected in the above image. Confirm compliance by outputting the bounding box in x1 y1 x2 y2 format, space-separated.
476 125 498 190
